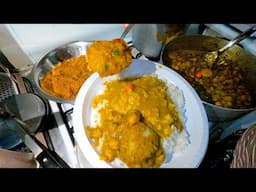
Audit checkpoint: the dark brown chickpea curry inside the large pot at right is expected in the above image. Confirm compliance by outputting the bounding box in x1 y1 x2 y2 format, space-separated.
168 50 255 109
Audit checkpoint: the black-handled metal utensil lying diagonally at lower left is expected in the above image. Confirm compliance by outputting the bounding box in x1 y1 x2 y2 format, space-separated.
0 103 69 168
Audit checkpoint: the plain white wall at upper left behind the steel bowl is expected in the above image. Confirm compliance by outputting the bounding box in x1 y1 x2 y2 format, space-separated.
0 24 130 67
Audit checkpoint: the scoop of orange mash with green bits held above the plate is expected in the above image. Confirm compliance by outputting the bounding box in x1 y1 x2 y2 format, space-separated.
87 39 132 77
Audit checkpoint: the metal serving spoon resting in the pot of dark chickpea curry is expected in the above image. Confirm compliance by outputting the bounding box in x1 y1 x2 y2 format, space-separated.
205 25 256 68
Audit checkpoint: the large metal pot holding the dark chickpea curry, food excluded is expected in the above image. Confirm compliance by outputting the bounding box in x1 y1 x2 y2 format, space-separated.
161 35 256 122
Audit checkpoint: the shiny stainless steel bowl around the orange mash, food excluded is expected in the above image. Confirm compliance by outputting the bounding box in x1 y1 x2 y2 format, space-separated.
32 41 92 104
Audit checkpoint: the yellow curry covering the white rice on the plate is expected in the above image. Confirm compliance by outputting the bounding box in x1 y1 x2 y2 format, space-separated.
85 76 183 168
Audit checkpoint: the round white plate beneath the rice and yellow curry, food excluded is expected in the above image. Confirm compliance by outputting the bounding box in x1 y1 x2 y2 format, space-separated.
73 59 209 168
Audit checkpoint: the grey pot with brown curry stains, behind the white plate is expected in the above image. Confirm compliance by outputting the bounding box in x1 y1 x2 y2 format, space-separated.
132 24 188 60
